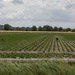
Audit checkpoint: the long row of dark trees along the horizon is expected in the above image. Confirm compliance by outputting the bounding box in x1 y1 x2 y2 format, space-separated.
0 24 75 32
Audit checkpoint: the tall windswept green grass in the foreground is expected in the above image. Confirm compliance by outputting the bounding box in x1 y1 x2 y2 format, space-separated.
0 61 75 75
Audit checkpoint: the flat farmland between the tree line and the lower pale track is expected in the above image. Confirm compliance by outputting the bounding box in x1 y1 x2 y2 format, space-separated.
0 32 75 58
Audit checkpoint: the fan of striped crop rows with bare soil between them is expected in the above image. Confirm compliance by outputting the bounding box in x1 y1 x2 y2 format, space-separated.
20 36 75 53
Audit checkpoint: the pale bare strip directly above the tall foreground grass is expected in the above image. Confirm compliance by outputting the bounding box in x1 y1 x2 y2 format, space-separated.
0 58 75 62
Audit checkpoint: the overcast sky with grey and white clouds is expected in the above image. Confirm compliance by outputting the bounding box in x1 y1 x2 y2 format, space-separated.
0 0 75 28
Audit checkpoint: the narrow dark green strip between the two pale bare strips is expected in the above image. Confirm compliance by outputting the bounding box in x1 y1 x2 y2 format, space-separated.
0 53 75 58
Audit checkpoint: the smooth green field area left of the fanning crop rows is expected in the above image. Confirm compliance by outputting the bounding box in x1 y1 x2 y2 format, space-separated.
0 33 47 50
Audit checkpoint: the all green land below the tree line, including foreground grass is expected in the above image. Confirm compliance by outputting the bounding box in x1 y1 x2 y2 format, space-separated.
0 32 75 75
